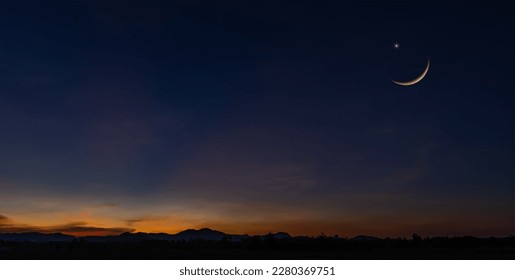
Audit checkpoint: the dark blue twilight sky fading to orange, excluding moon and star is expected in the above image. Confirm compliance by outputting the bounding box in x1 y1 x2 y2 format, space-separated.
0 0 515 237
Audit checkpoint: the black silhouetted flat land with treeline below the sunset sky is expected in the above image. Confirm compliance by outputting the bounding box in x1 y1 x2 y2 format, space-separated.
0 236 515 260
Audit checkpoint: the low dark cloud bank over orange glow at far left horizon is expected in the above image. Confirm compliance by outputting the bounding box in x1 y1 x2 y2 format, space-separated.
0 215 134 236
